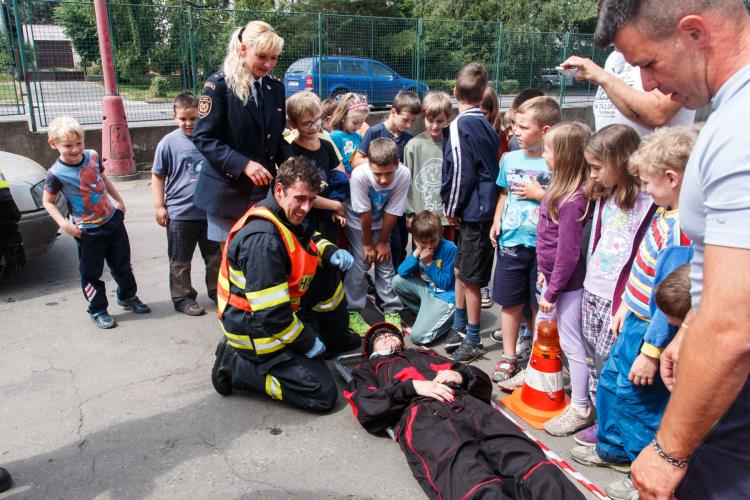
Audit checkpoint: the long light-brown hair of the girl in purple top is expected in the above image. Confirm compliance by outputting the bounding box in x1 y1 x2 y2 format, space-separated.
544 122 591 224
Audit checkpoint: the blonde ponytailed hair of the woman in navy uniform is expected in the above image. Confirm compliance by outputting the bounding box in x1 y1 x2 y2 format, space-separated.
222 21 284 104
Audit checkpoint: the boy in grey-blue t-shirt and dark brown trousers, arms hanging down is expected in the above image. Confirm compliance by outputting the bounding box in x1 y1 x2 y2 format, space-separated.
151 92 221 316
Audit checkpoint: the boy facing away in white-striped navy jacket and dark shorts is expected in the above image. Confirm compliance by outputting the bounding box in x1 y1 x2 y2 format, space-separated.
440 63 500 363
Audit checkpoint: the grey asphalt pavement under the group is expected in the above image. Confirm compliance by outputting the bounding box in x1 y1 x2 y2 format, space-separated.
0 180 622 499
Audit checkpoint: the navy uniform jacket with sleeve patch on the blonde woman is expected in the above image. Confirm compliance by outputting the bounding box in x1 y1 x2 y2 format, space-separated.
193 72 292 219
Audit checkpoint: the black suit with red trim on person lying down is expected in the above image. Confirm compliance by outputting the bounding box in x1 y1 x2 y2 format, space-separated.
344 349 584 500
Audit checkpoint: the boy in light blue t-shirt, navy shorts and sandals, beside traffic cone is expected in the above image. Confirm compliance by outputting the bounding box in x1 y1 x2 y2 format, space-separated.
490 96 561 382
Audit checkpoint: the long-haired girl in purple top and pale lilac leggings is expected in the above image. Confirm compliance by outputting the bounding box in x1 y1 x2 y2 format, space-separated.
536 122 594 436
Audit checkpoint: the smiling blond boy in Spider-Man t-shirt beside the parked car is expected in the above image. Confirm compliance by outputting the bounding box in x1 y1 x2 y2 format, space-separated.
42 116 151 328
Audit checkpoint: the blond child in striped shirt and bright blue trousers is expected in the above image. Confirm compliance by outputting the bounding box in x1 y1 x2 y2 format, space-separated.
571 127 696 481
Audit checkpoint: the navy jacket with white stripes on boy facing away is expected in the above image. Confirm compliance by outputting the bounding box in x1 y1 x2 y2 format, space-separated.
440 108 500 222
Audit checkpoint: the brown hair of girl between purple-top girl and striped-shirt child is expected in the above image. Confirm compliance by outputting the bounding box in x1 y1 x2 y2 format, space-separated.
585 124 641 210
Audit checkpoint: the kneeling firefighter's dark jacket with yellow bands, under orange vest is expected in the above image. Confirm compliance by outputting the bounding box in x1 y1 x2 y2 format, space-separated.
222 192 338 361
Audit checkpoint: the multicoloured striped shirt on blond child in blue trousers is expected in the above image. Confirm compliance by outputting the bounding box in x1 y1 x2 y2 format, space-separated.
623 207 690 321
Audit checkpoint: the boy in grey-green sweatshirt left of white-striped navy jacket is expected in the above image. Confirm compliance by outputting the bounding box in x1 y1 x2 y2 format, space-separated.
404 92 454 241
